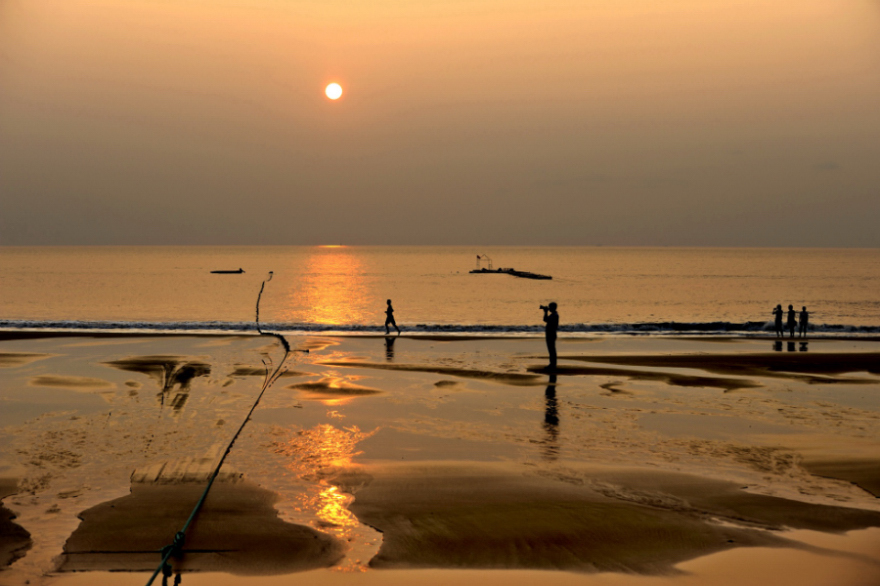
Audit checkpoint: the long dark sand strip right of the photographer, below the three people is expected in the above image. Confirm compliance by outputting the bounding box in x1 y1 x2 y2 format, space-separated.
560 352 880 383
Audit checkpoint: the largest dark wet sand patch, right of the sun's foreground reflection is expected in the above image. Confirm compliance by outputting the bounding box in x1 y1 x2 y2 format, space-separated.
337 464 880 574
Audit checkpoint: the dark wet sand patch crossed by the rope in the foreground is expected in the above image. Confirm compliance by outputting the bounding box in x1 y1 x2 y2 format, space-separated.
59 482 345 575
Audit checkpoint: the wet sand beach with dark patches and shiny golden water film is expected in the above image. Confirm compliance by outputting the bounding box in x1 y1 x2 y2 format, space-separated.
0 334 880 586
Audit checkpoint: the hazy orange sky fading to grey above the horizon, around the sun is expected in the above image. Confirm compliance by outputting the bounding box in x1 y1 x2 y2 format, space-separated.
0 0 880 247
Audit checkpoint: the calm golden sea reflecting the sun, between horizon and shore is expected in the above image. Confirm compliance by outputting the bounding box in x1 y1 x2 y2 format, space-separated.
0 246 880 336
